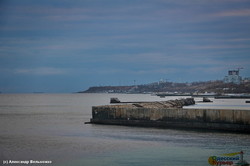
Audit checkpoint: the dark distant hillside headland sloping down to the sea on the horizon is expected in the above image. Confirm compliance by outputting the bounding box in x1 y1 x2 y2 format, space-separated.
80 81 250 94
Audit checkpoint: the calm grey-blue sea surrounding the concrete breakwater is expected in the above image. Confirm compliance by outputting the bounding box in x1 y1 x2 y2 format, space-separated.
0 93 250 166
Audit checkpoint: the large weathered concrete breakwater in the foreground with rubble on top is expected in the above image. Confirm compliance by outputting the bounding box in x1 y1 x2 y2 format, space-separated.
90 99 250 133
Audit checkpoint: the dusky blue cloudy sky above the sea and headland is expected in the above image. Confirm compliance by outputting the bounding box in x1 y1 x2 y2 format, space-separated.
0 0 250 93
